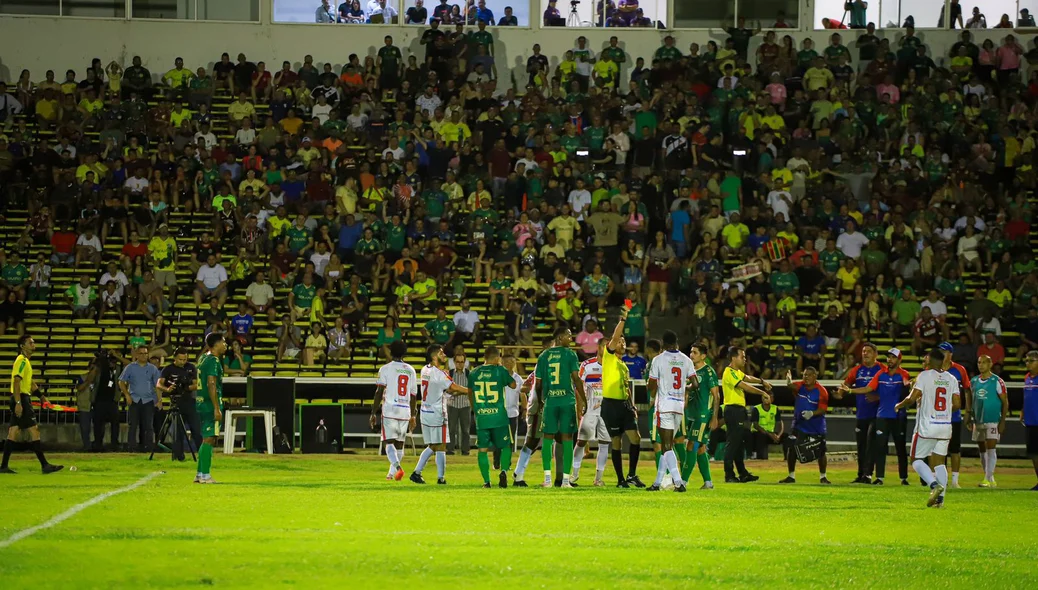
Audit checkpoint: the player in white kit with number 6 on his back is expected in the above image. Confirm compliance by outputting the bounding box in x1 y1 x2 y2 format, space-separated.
895 348 962 508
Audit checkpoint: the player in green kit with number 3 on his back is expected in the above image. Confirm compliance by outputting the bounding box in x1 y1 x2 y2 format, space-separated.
535 327 586 487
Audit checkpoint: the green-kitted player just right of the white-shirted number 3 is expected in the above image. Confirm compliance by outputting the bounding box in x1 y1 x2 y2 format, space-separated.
681 344 720 489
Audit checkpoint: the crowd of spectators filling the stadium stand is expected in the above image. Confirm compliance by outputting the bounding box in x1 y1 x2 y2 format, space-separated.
0 21 1038 377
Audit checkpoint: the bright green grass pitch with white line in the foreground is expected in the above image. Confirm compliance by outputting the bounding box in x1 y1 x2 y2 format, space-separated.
0 449 1038 590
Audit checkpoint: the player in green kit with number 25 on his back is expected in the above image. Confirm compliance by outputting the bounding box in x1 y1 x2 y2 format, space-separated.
468 346 522 487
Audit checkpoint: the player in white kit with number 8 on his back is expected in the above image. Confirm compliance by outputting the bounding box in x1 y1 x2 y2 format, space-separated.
371 341 418 481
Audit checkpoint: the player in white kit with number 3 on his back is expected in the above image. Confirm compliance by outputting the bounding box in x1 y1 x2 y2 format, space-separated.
647 330 699 491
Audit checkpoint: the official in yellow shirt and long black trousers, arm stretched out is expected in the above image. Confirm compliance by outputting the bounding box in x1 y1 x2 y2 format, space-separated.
720 348 771 483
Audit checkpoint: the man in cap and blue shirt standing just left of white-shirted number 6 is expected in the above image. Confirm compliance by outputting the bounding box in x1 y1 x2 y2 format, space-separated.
850 348 911 485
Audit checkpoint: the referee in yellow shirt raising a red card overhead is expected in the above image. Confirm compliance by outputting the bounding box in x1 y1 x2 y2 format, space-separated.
598 310 646 487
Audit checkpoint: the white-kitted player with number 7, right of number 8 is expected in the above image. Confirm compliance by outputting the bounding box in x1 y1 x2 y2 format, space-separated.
411 344 469 485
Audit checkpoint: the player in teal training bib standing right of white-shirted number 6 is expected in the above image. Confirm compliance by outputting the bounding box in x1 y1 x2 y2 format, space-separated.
962 354 1009 487
